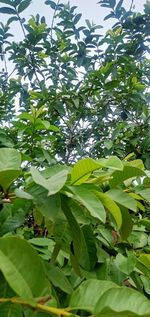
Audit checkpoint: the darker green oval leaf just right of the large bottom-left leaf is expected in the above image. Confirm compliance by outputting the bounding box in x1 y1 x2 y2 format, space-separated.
46 264 73 294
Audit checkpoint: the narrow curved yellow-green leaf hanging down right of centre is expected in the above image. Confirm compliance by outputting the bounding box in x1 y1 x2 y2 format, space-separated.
96 192 122 229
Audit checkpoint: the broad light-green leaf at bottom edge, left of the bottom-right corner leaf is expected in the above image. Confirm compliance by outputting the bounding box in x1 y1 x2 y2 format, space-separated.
69 279 118 313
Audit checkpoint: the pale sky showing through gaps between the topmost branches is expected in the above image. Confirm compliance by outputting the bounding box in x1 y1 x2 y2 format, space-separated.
0 0 146 73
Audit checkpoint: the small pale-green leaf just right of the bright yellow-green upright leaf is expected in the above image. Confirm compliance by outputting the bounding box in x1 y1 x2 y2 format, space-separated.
98 156 124 171
